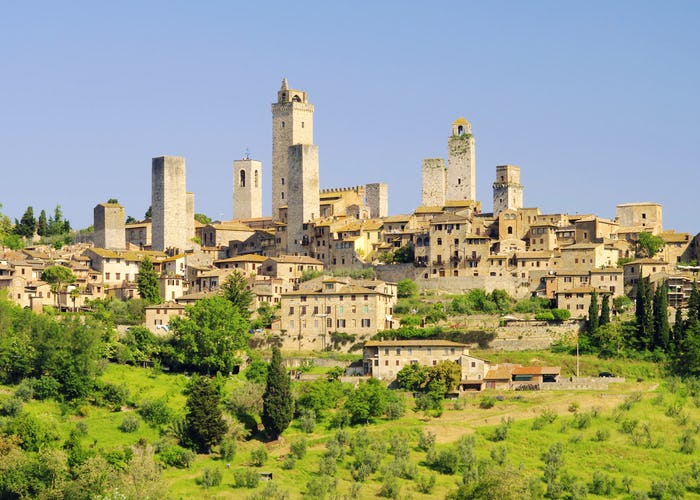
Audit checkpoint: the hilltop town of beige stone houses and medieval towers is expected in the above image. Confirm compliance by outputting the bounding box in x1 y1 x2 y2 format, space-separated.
0 80 700 348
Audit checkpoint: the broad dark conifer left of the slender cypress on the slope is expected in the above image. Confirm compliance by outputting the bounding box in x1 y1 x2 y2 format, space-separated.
185 375 228 453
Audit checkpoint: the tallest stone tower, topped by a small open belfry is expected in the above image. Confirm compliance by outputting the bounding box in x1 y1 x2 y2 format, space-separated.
272 78 318 220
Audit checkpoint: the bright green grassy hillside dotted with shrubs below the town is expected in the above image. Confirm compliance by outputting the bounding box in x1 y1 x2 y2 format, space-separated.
0 352 700 499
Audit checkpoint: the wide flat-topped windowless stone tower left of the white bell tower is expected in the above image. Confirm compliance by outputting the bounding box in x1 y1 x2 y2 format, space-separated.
151 156 187 251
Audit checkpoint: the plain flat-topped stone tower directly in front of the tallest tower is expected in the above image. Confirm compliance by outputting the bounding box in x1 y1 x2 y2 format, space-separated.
287 144 320 255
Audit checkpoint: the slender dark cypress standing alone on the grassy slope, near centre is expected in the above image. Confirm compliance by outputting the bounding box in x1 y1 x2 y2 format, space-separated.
262 347 294 439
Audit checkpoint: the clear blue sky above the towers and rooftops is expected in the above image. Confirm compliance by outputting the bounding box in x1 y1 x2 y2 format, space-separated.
0 0 700 234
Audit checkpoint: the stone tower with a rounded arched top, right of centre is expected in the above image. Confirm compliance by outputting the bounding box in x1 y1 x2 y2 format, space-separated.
446 118 476 201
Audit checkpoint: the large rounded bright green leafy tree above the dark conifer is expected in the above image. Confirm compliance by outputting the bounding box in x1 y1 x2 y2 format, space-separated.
170 295 250 373
